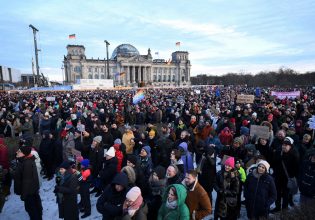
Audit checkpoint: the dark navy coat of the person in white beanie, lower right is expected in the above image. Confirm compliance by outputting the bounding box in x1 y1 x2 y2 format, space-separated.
244 169 277 219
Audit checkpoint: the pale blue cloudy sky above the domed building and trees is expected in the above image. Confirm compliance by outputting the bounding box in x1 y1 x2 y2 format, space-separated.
0 0 315 80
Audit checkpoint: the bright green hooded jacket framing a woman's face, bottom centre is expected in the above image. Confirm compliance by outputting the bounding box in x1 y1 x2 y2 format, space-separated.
158 184 190 220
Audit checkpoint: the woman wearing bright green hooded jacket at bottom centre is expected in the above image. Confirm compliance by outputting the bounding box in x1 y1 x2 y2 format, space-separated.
157 184 190 220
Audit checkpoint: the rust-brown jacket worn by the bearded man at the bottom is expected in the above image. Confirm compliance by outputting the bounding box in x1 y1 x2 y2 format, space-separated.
186 180 211 220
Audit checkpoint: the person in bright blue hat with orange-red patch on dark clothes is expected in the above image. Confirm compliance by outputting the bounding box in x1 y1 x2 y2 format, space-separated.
79 159 91 218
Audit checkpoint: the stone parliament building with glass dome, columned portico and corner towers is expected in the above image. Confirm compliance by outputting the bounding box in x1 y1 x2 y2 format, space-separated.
63 44 191 86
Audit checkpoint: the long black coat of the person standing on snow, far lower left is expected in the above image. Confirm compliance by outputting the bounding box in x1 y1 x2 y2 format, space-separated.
14 154 39 200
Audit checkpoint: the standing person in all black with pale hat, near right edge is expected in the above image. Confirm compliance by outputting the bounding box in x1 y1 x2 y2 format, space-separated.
272 137 299 212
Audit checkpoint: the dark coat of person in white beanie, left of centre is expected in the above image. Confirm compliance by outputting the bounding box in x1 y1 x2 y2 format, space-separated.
99 157 118 188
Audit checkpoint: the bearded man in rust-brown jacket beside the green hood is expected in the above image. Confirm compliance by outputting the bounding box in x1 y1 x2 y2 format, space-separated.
183 170 212 220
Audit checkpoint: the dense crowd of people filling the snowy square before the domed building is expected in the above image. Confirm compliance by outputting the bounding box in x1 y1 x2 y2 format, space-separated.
0 87 315 220
